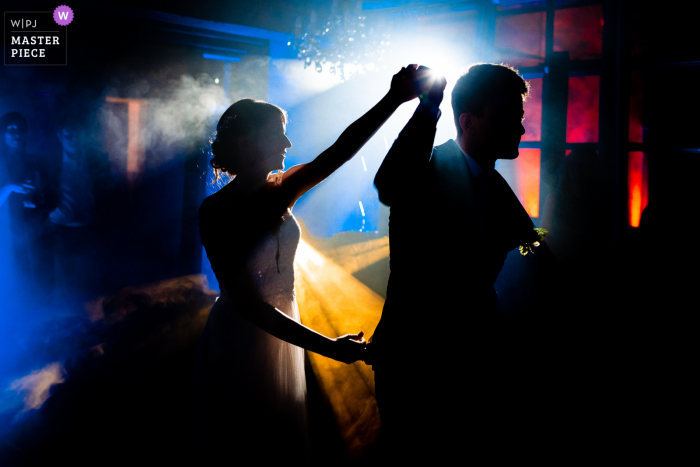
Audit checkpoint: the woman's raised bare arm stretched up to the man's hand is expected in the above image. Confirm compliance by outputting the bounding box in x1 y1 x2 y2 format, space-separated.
282 65 427 206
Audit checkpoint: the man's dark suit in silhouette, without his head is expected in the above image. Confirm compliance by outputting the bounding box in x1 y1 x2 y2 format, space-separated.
371 104 533 458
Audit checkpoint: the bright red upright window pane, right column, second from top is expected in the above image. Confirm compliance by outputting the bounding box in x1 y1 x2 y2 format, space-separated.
566 76 600 143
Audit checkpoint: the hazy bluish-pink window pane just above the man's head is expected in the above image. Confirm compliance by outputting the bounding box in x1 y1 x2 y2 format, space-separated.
494 12 547 67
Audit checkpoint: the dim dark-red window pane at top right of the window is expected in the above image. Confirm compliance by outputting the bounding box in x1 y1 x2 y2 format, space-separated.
554 5 603 60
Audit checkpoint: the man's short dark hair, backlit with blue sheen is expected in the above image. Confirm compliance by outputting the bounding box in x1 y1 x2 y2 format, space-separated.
452 63 530 134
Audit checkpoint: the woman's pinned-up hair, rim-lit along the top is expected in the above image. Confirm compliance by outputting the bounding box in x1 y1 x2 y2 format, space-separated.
210 99 287 179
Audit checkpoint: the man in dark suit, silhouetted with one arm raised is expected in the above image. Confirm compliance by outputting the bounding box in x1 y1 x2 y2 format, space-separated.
371 64 535 463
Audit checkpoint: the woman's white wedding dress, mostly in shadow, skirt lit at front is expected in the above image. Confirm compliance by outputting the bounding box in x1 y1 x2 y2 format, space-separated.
195 174 307 464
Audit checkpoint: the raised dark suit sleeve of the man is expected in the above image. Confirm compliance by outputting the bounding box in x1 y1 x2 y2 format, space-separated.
374 101 440 206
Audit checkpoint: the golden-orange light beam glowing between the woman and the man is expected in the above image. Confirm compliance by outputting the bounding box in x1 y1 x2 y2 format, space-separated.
295 239 388 458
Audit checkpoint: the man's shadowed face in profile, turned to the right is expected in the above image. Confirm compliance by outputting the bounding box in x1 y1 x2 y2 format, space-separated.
470 94 525 159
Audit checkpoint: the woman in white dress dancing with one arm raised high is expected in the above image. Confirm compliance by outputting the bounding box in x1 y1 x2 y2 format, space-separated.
194 65 418 465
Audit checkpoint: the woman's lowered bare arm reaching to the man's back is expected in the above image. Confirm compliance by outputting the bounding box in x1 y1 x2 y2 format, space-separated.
224 271 366 363
